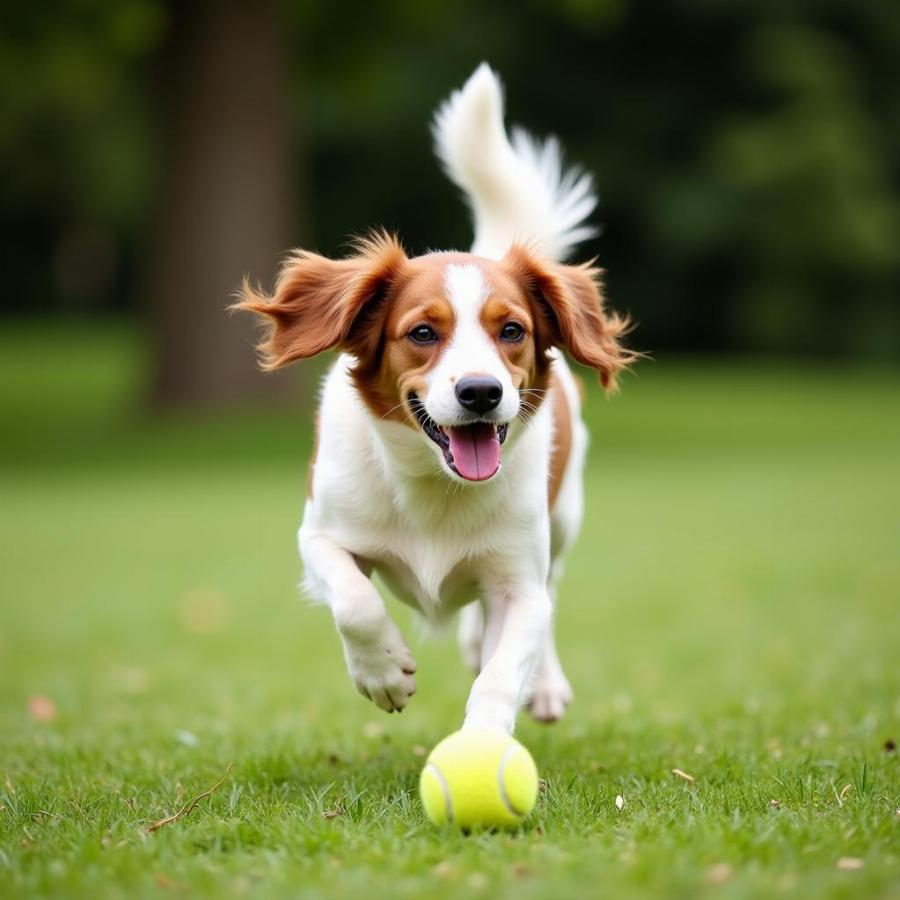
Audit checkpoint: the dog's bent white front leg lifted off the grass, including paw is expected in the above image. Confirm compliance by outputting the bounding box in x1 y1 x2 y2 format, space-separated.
300 530 416 712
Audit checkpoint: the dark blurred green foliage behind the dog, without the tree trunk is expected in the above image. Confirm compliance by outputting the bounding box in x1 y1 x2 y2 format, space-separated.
0 0 900 358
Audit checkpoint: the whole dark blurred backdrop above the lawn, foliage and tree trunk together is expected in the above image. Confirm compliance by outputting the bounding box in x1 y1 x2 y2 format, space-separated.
0 0 900 406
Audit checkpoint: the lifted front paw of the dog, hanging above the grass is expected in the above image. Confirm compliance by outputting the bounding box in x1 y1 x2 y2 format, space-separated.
344 619 416 712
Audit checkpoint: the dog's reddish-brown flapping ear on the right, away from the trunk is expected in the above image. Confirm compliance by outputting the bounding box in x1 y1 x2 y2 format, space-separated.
503 245 638 390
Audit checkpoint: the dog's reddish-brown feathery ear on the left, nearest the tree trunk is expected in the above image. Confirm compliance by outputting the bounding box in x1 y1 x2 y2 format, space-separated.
232 233 407 370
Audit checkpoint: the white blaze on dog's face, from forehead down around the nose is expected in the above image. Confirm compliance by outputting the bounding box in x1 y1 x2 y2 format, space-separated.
424 264 519 425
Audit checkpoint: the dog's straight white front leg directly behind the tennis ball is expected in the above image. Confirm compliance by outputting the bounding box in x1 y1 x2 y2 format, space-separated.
463 582 552 734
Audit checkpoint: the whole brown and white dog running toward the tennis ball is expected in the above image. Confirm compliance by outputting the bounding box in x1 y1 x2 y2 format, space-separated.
236 64 635 733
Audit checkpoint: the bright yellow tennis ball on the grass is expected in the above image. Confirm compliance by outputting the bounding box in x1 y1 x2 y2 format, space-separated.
419 729 538 829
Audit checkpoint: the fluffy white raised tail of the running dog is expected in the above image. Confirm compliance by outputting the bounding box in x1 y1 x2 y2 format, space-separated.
433 63 597 260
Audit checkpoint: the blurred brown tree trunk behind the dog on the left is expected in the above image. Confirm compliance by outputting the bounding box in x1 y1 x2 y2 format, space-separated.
146 0 296 408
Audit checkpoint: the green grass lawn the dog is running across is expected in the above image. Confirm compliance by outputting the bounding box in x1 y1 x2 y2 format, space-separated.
0 326 900 898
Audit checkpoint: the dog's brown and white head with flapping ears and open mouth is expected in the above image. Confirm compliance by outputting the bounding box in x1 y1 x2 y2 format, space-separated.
237 234 632 482
